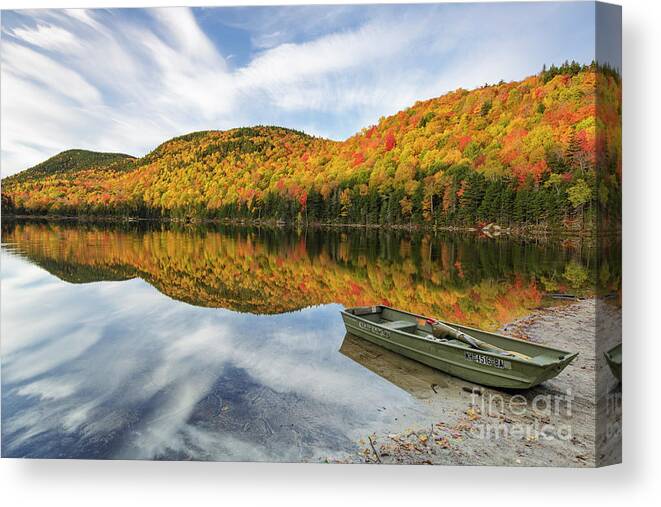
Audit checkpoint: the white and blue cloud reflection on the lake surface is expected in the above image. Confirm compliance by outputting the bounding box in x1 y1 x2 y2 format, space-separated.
2 252 424 461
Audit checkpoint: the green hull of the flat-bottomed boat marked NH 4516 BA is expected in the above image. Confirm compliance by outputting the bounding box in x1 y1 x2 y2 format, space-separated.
342 312 576 389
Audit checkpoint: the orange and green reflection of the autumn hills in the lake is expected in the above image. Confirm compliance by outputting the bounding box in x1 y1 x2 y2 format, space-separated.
3 223 619 329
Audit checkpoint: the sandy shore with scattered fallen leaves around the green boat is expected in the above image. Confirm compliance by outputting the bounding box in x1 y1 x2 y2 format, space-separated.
329 299 617 467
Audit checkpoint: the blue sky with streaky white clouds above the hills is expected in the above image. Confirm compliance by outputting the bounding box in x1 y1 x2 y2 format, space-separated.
0 2 595 176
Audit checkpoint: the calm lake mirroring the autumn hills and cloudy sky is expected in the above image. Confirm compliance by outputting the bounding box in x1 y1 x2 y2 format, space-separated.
2 221 619 461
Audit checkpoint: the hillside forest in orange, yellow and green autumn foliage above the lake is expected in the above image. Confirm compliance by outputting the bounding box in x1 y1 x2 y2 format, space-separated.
2 63 621 229
